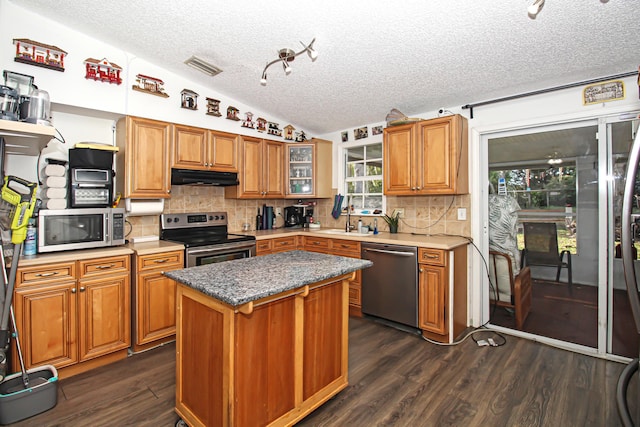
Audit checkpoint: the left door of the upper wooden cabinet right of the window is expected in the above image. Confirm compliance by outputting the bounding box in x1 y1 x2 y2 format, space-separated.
383 124 416 195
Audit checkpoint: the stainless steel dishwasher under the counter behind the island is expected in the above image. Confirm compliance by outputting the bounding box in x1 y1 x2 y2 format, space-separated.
361 242 418 328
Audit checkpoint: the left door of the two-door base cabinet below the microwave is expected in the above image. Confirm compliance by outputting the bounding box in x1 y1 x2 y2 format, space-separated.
13 281 78 371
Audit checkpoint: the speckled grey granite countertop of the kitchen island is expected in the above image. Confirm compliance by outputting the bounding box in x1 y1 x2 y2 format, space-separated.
164 251 373 307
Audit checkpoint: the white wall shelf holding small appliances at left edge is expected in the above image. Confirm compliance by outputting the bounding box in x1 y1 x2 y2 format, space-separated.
0 120 56 156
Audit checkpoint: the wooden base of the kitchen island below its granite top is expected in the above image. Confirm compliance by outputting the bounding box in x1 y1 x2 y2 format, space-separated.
176 275 349 426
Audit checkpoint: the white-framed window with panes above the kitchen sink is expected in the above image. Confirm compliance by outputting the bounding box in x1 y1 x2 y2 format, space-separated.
344 142 384 215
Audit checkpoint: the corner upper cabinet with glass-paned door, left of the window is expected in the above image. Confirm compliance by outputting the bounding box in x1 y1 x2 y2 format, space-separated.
285 138 332 199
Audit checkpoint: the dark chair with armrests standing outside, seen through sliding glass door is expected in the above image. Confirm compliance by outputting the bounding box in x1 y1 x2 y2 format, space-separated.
522 222 573 288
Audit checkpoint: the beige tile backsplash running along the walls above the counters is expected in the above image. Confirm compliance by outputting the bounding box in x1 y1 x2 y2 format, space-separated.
127 185 471 239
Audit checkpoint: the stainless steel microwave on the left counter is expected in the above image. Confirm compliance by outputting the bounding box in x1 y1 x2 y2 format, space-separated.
38 208 125 253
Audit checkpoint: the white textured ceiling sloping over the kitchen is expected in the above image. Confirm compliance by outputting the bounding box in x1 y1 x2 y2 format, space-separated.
11 0 640 134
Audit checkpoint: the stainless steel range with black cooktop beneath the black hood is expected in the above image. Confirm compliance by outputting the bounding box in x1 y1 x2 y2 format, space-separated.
160 212 256 267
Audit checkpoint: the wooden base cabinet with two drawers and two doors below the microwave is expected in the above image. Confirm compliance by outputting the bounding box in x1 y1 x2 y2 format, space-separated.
13 255 130 375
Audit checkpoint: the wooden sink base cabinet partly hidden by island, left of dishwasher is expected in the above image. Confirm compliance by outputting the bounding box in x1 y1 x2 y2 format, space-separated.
302 236 362 317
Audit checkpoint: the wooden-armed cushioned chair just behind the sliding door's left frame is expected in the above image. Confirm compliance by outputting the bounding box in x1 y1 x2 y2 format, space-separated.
489 251 532 330
